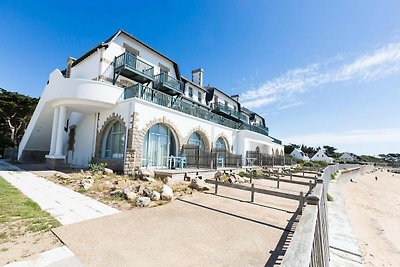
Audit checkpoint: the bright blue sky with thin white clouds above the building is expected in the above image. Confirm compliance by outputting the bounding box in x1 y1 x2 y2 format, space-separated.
0 0 400 155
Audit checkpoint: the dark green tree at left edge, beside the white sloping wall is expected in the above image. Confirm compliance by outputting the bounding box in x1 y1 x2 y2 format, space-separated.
0 88 39 148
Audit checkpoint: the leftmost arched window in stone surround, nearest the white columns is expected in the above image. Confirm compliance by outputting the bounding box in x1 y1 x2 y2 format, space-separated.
102 121 125 159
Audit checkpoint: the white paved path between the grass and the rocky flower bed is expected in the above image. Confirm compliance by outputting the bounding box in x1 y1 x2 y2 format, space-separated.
0 161 119 225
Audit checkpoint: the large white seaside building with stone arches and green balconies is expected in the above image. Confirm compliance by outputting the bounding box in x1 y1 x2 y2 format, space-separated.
18 30 283 172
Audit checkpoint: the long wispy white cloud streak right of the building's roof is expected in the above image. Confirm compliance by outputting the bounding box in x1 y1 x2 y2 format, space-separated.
241 43 400 108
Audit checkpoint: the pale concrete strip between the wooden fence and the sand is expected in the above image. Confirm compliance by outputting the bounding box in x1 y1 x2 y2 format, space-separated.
328 172 363 267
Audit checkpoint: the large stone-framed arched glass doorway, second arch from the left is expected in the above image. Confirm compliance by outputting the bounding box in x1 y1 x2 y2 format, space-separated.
142 123 177 167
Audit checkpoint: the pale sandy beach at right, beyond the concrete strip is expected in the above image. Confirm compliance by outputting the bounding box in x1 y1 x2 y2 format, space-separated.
341 170 400 266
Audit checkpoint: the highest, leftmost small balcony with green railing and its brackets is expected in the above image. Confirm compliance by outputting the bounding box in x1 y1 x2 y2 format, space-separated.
113 52 154 84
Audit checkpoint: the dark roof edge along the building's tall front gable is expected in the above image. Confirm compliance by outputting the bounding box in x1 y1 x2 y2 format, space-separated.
72 29 181 79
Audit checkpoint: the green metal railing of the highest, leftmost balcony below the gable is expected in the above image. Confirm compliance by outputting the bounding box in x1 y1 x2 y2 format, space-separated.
114 52 154 80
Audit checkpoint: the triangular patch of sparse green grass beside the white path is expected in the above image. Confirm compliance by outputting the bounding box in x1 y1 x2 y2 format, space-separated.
0 177 60 244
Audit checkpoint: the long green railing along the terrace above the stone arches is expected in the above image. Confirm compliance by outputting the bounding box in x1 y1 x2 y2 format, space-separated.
124 84 280 140
